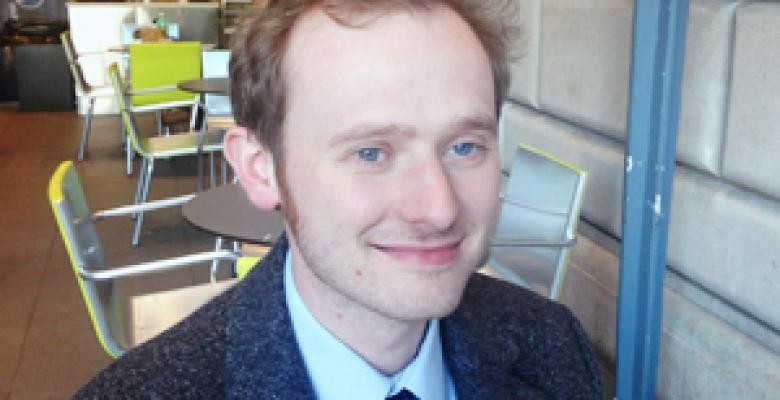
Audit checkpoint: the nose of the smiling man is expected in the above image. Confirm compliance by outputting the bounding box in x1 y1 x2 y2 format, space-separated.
397 160 460 232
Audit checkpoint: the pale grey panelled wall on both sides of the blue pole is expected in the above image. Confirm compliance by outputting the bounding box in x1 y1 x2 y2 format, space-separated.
500 0 780 399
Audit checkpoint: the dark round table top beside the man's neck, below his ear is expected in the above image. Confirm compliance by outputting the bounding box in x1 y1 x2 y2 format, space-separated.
182 185 284 244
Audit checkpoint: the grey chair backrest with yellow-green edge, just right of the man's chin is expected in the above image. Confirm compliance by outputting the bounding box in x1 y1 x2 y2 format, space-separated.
488 144 588 300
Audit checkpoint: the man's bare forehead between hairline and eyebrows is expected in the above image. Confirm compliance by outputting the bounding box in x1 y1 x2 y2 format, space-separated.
282 6 494 137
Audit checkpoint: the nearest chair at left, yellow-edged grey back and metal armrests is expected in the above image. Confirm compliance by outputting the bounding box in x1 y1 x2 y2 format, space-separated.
48 161 238 357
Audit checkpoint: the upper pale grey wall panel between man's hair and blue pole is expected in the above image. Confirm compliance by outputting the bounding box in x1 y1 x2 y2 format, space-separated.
540 0 633 139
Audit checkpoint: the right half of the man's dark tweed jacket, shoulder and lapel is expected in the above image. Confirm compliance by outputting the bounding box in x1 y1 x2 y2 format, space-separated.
444 274 602 399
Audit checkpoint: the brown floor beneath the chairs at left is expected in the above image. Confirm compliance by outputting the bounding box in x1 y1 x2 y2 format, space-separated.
0 105 213 400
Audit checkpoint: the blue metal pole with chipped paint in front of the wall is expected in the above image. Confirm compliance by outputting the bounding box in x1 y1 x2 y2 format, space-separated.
616 0 688 400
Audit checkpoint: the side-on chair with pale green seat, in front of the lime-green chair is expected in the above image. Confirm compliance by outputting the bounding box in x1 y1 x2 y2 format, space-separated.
108 63 223 246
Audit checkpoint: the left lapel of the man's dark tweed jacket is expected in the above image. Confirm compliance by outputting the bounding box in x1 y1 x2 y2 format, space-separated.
225 235 314 399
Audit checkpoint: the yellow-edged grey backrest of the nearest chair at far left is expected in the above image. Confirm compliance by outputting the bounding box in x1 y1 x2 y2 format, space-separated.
49 161 129 357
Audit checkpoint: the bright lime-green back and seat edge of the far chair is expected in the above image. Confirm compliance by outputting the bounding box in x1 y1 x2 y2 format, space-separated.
128 42 201 106
